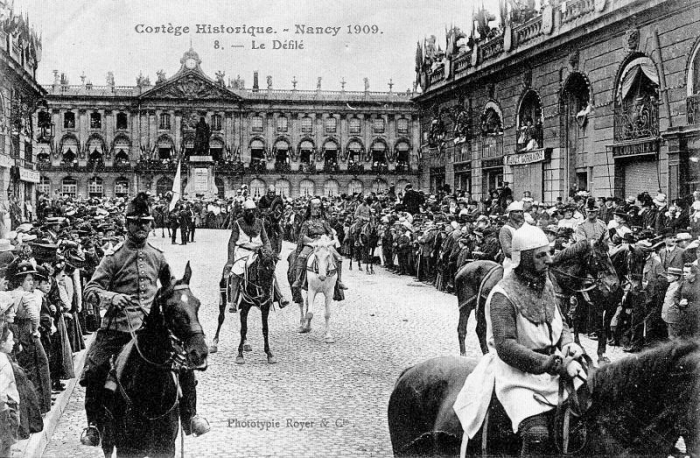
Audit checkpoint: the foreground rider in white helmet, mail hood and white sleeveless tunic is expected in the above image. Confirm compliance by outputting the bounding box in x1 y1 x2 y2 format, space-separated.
454 225 583 456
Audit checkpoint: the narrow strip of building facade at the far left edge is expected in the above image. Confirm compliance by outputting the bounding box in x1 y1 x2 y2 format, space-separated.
0 1 43 233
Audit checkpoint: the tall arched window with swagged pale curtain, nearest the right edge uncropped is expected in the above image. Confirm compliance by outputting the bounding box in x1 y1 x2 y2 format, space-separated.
615 57 659 141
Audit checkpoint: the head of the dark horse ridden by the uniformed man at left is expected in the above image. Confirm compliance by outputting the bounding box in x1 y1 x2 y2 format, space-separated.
153 261 209 370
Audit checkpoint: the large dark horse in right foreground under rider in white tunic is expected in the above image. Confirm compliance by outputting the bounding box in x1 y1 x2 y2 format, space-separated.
388 340 700 457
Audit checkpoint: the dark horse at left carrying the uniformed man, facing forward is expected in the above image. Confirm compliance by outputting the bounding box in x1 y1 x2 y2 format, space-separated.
102 262 208 457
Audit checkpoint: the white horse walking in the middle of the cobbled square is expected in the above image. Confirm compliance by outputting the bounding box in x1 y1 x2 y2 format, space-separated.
299 235 338 343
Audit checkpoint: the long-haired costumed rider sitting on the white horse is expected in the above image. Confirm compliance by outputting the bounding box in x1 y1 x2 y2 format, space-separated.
292 198 348 292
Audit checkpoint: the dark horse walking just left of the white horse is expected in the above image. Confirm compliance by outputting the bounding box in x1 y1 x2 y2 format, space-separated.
210 248 279 364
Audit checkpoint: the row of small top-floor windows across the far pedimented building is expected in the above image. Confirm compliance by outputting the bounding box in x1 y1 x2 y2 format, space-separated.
63 111 408 134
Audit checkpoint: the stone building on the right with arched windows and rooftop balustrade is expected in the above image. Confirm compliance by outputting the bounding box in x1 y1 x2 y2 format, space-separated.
415 0 700 202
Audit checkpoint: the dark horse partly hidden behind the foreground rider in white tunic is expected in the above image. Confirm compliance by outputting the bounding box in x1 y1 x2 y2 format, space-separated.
455 238 619 359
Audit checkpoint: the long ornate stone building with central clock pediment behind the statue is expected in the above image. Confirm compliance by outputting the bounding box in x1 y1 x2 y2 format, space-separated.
37 49 420 197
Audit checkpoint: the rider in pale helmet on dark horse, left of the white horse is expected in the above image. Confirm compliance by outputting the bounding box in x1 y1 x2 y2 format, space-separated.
220 199 289 312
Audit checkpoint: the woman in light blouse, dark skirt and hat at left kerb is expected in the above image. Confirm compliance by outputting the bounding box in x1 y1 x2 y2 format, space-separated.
13 262 51 413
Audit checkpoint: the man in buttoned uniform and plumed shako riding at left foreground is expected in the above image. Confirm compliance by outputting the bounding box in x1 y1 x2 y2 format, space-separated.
80 193 209 446
